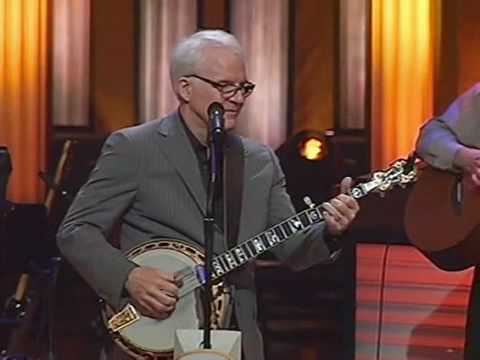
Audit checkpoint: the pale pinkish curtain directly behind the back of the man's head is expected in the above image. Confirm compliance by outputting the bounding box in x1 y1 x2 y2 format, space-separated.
139 0 197 121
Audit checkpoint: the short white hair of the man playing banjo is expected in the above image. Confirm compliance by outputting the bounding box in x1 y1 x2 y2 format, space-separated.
170 30 243 83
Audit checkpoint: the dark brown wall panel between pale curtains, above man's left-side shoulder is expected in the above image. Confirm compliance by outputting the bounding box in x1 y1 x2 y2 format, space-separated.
91 0 137 134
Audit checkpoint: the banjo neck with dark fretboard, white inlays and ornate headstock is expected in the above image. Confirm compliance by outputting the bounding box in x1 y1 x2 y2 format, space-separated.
208 180 374 280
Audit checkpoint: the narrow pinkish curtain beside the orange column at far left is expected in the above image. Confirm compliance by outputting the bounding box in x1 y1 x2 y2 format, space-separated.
52 0 90 126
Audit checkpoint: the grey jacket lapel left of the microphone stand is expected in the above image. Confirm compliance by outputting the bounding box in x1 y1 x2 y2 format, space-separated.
157 113 207 214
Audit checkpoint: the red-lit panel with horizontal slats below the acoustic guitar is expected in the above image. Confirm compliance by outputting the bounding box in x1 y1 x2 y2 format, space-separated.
356 244 473 360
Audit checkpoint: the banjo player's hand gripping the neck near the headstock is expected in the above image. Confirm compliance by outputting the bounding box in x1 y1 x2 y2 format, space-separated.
323 177 360 236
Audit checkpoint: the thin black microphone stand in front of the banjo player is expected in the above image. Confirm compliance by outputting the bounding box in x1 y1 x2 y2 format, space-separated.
203 127 224 349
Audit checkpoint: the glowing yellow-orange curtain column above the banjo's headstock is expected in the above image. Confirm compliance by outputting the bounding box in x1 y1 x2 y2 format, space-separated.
372 0 440 168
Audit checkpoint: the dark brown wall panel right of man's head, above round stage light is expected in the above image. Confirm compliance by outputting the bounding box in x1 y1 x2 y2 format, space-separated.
290 0 338 133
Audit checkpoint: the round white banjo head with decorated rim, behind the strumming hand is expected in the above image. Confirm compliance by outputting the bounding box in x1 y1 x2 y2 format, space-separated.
102 240 226 359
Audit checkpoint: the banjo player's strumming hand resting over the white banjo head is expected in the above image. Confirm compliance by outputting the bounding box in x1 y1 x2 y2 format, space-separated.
125 266 178 320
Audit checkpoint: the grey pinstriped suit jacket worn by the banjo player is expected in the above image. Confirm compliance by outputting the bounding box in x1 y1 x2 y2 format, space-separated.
57 113 330 360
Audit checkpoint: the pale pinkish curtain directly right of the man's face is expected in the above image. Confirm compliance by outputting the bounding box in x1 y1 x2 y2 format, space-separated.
231 0 288 148
